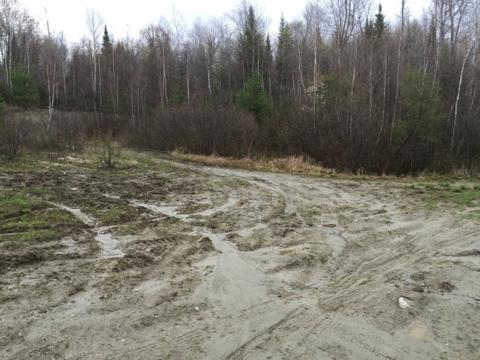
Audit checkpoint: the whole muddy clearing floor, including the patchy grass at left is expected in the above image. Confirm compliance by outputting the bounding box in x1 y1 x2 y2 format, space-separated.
0 152 480 360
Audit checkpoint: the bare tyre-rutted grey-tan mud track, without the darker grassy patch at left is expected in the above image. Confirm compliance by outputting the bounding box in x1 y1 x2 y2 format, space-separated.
0 155 480 359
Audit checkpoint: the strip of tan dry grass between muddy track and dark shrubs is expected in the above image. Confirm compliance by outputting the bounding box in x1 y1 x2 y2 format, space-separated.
170 151 338 177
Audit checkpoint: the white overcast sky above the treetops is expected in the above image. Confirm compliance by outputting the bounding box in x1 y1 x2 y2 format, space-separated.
21 0 430 42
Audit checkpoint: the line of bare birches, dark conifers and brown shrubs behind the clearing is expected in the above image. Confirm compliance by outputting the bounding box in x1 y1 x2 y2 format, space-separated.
0 0 480 173
